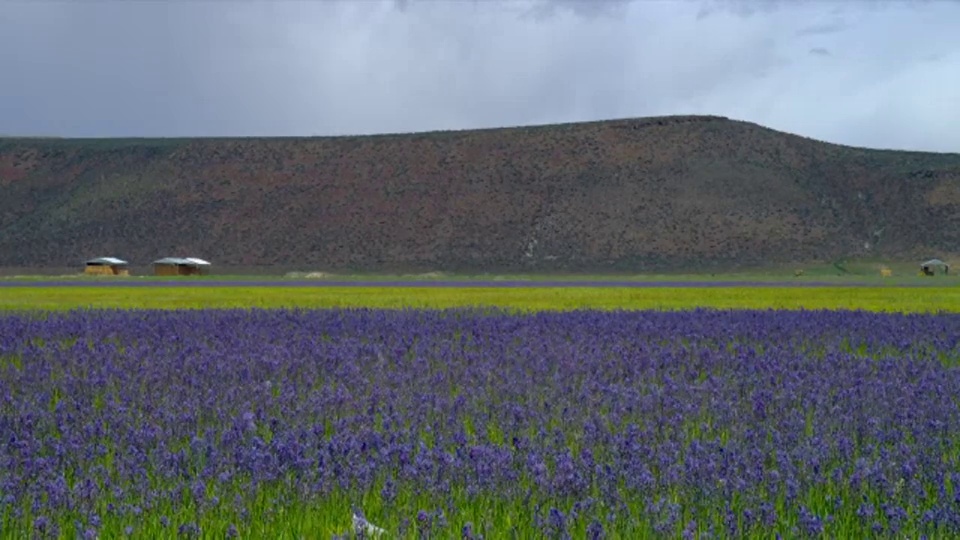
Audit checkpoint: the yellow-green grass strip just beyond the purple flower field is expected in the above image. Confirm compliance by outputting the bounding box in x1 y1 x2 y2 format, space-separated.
0 286 960 312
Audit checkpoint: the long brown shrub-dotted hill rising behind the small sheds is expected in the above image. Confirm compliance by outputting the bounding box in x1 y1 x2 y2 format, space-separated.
0 116 960 272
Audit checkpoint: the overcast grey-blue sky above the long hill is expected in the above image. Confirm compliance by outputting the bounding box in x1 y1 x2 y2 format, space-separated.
0 0 960 152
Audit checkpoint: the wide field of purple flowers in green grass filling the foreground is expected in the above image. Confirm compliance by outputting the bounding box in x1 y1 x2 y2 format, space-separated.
0 309 960 539
